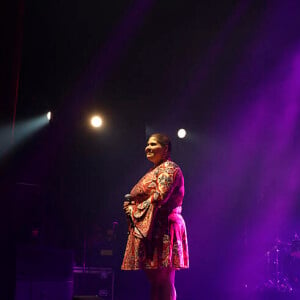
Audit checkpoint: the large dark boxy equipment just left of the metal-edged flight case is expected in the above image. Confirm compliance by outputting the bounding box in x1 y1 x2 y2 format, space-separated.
15 245 73 300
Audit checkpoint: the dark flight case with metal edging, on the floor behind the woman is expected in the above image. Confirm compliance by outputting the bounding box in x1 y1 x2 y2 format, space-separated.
73 267 114 300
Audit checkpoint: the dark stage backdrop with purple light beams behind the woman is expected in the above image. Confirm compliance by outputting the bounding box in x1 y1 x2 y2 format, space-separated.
0 0 300 300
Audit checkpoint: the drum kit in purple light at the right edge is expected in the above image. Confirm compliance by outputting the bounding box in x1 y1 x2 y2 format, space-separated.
264 236 300 293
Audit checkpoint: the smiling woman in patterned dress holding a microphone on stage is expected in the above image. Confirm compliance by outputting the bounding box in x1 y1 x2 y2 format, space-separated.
121 133 189 300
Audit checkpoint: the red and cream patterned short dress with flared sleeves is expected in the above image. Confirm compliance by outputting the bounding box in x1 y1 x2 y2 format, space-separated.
121 160 189 270
